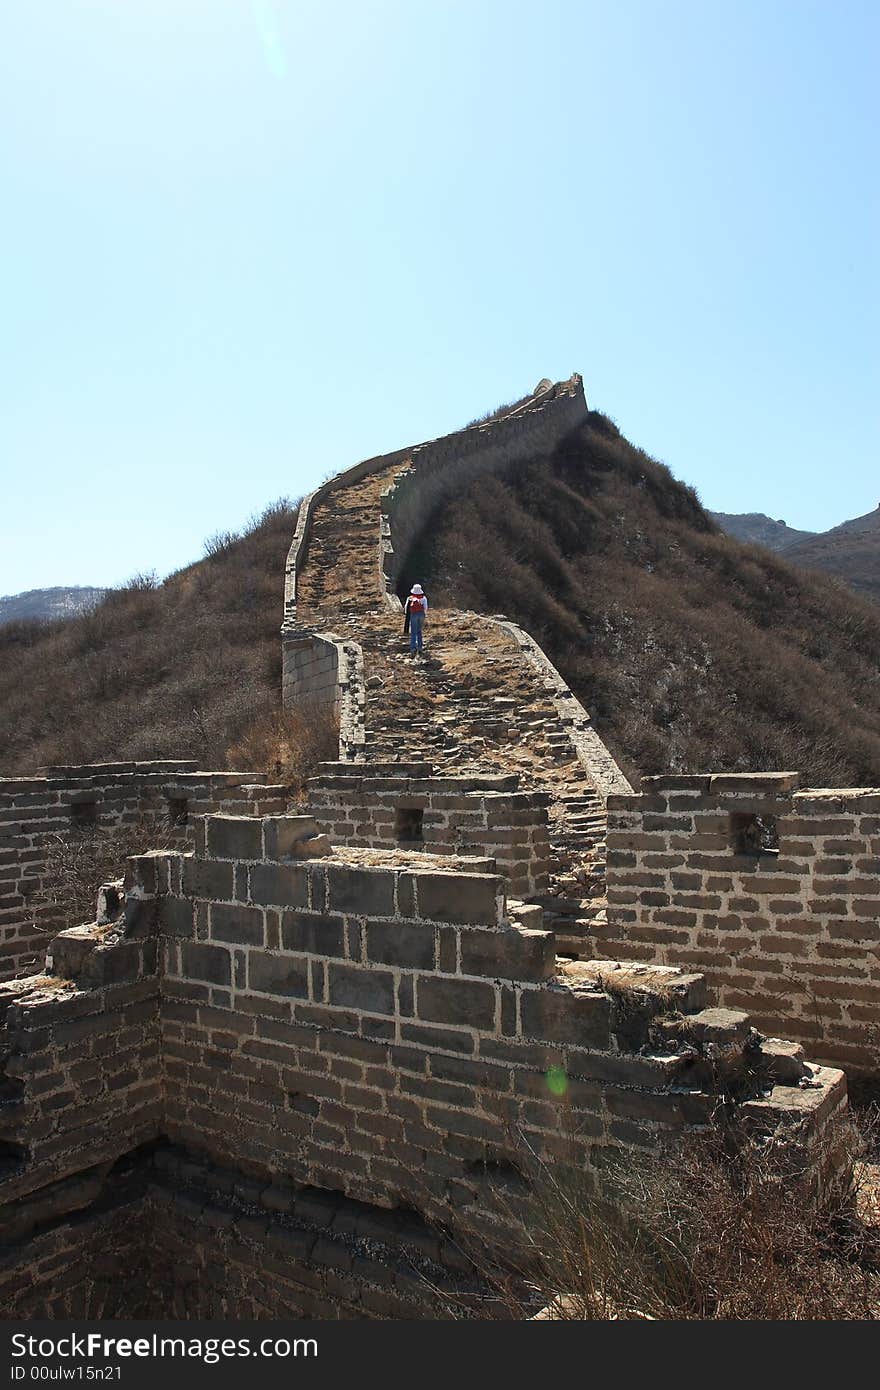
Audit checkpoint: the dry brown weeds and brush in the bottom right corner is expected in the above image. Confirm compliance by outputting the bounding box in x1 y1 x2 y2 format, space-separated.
446 1116 880 1321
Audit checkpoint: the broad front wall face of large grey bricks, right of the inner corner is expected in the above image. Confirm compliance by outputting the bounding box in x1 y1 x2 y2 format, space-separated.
142 816 836 1220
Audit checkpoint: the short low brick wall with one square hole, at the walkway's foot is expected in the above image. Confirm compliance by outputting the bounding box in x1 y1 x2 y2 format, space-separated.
307 763 551 898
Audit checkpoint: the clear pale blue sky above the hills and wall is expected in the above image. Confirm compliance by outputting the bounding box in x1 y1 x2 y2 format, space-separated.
0 0 880 594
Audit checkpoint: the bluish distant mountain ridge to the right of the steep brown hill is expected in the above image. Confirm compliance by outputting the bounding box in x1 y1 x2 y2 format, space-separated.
709 507 880 599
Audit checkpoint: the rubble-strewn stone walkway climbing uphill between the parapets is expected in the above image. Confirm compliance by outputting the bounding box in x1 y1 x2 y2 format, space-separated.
298 461 605 949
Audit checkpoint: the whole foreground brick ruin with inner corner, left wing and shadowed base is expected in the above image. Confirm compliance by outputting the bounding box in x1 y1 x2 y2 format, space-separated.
0 815 845 1316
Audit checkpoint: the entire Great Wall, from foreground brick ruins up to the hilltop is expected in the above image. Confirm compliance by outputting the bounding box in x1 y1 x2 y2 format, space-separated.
0 375 880 1318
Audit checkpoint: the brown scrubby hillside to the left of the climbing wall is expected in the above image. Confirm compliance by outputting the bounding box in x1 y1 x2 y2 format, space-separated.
0 503 296 776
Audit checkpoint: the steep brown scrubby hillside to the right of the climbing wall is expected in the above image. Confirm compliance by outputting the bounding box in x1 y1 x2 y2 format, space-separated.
413 413 880 785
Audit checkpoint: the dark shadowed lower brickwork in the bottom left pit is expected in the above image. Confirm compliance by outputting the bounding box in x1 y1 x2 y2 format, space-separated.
0 1143 469 1321
